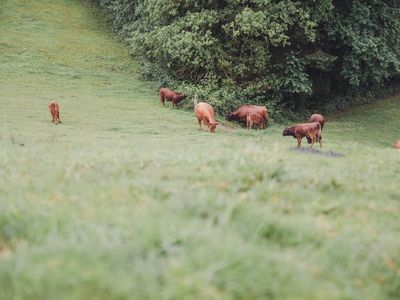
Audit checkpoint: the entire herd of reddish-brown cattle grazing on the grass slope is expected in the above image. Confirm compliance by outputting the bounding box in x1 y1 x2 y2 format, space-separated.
49 88 400 149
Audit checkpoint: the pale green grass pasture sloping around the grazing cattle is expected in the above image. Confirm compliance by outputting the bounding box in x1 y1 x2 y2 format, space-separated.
0 0 400 300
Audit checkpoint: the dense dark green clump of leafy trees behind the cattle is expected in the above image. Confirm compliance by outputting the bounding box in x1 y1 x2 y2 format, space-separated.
98 0 400 115
